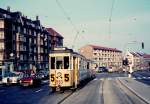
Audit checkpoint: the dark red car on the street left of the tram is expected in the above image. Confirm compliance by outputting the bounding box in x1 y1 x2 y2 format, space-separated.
20 74 41 87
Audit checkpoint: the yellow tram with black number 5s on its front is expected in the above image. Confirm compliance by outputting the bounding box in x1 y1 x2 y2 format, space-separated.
49 47 93 91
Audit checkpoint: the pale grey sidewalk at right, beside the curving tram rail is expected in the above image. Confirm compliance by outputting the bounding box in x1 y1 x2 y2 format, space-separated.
119 78 150 104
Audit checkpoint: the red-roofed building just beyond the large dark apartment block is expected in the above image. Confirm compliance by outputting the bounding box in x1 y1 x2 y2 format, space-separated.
46 28 64 49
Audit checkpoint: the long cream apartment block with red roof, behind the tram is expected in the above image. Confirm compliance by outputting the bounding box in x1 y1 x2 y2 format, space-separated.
79 45 122 71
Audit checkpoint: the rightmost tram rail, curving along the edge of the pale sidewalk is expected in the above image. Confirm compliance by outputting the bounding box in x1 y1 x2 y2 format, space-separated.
117 79 149 104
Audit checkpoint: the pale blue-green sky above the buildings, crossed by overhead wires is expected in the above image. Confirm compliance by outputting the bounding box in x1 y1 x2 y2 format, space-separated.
0 0 150 53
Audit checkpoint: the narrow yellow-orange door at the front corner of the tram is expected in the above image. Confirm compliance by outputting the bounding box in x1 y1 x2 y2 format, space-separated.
73 56 78 88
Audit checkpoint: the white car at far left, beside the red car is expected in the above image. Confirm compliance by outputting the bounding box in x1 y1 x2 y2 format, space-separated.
2 73 23 85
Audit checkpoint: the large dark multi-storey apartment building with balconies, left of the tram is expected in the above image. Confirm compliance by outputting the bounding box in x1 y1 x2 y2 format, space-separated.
0 8 63 70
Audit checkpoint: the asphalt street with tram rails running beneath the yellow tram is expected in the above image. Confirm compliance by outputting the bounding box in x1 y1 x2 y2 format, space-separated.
0 73 149 104
